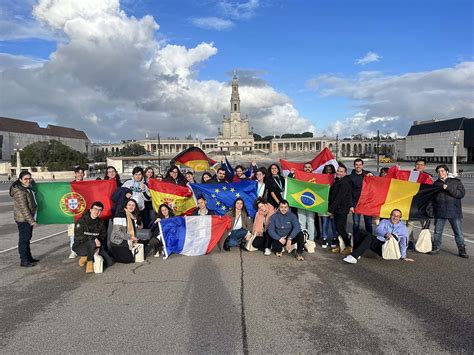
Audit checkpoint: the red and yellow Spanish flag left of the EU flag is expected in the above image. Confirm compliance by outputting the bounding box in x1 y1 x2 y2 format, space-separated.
148 179 196 216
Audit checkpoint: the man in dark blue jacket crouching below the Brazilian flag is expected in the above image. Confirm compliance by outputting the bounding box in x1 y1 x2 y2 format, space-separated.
267 200 304 261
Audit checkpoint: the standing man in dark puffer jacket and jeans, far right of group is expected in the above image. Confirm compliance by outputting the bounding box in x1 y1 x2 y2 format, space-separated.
429 164 469 259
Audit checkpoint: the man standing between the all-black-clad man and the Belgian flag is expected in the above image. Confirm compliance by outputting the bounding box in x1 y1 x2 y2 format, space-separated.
349 158 373 245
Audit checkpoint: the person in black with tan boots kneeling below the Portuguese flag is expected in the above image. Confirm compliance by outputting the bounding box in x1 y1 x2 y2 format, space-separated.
72 201 113 273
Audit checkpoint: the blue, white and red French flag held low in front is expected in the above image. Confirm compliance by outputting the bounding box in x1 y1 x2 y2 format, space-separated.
160 216 232 259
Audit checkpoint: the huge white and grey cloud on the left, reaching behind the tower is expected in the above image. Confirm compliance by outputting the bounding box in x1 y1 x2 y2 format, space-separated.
0 0 314 141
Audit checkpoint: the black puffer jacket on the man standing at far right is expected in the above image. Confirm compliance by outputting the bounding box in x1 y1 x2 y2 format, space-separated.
433 178 466 218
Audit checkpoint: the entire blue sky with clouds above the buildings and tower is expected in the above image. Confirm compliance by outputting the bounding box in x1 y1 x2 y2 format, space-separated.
0 0 474 141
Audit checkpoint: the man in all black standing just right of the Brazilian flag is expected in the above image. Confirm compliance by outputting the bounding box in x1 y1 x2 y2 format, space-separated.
328 164 352 255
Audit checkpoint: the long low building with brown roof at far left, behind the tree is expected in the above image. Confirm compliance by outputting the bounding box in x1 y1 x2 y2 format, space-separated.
0 117 90 161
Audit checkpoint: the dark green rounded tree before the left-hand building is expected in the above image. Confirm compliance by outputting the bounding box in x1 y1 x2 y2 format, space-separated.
11 139 89 171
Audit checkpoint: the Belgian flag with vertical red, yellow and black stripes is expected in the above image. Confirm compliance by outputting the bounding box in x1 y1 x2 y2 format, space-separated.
355 176 440 220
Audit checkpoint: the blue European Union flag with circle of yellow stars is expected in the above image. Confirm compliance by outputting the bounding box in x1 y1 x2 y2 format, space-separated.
190 180 257 218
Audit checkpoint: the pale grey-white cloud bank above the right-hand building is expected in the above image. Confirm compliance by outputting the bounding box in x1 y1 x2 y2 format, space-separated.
308 62 474 135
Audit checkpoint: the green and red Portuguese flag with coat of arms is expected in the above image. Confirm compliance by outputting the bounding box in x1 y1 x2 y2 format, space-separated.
33 180 117 224
